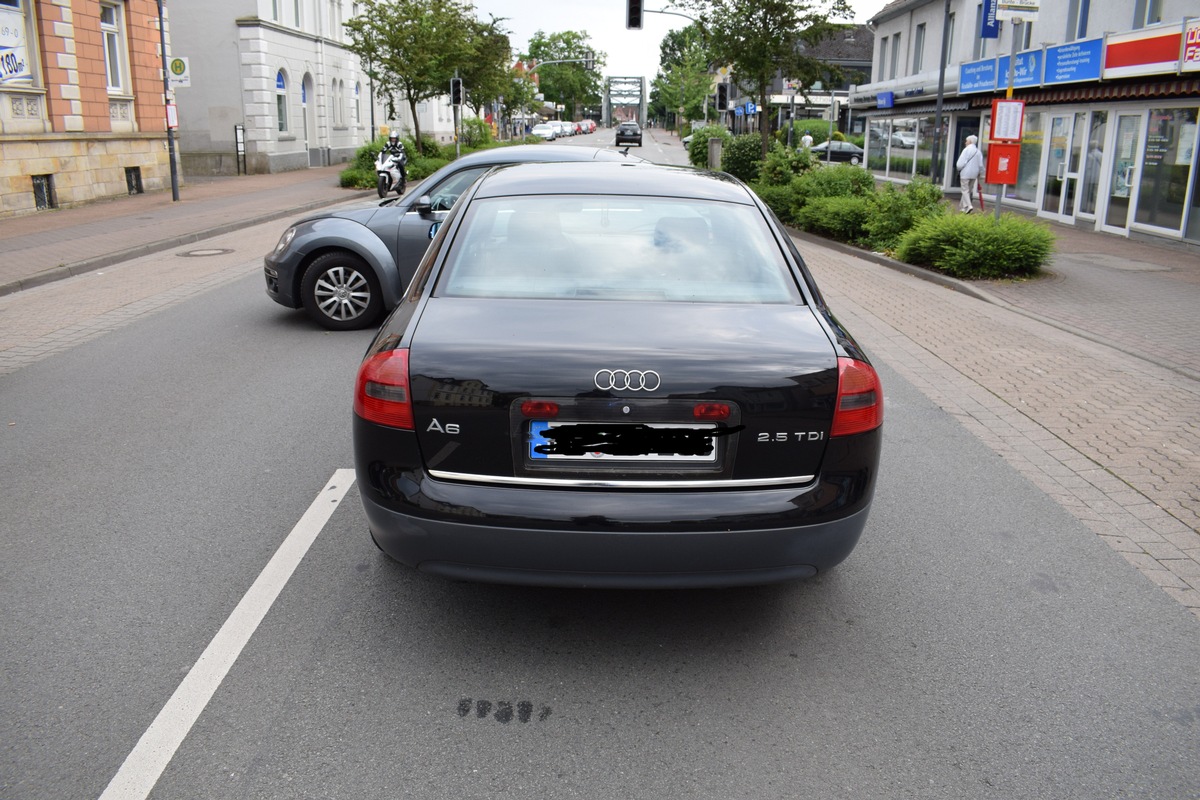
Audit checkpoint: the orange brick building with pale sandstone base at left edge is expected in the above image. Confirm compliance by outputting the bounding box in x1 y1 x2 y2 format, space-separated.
0 0 170 217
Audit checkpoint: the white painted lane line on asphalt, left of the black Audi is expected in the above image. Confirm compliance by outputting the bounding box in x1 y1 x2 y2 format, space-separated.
100 469 354 800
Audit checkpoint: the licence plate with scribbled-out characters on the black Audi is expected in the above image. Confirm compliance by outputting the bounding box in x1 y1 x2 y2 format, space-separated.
529 420 716 463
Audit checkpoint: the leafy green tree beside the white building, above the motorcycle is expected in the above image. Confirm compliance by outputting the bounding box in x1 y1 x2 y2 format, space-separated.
346 0 476 150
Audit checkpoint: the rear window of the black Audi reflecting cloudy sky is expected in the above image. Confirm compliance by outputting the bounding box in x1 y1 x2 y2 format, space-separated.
437 196 803 303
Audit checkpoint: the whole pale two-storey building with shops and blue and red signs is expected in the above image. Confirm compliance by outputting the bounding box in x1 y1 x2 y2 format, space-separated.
851 0 1200 245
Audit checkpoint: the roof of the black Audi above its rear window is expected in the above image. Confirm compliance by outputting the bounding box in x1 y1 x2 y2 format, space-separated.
475 161 754 205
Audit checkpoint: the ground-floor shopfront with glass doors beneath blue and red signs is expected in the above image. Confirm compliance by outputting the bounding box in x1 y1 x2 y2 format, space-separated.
852 19 1200 242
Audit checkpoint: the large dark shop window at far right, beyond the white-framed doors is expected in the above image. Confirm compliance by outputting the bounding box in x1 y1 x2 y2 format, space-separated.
1134 108 1196 230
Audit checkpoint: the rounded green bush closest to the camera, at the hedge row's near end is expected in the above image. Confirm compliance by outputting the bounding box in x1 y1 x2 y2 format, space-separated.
896 213 1055 279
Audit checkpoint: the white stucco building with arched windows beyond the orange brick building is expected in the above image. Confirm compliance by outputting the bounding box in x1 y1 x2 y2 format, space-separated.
169 0 454 175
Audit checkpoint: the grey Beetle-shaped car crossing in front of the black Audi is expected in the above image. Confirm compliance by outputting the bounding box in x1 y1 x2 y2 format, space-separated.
263 144 641 330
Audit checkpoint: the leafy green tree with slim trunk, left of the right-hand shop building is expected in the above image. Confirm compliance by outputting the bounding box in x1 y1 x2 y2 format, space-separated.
680 0 852 158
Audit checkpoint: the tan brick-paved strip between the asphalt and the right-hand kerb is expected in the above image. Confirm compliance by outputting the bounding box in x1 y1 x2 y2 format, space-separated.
800 241 1200 618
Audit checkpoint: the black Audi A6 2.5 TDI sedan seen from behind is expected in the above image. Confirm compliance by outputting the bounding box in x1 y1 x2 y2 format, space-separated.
353 163 883 588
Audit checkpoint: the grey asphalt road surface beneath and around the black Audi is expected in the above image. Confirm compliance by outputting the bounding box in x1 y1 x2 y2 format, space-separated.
0 139 1200 800
